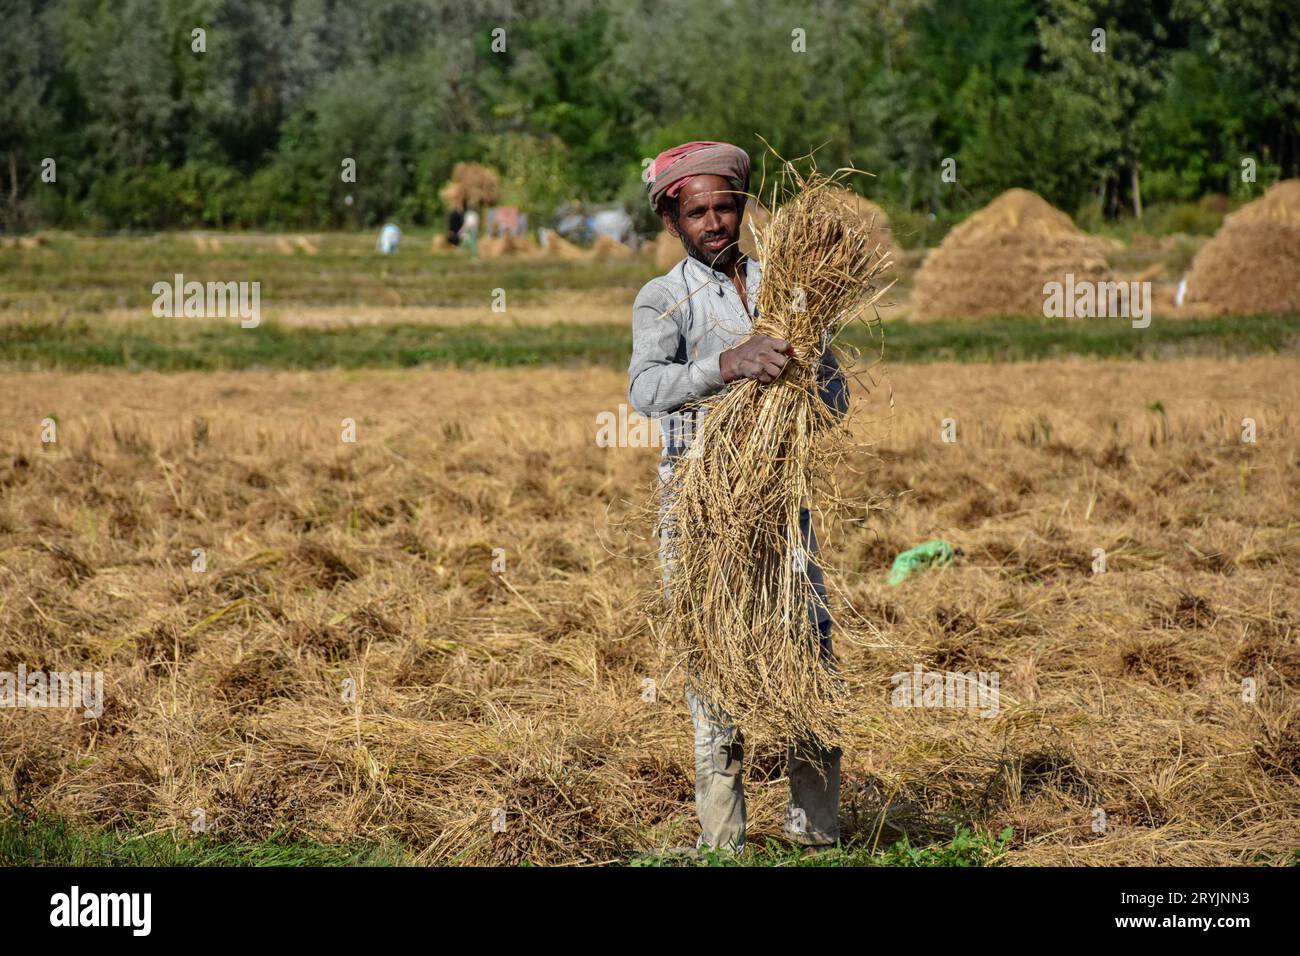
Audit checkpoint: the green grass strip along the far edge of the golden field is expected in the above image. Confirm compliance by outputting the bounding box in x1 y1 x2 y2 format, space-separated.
0 313 1300 372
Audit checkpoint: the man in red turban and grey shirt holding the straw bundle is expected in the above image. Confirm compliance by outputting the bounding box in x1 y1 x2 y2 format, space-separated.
628 142 848 852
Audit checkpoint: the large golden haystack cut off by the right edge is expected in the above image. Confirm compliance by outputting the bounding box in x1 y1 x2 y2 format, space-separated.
1184 179 1300 313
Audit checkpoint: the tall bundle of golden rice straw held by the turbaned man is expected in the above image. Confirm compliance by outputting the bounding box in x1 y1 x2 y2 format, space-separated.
659 161 892 747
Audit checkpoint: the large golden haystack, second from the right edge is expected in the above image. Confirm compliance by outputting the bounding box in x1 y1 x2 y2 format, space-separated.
911 189 1113 319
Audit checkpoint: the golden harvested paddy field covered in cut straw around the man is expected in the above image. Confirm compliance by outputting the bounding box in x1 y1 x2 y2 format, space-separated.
0 358 1300 865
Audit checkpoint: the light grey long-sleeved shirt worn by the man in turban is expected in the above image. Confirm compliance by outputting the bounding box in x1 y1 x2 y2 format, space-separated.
628 256 849 481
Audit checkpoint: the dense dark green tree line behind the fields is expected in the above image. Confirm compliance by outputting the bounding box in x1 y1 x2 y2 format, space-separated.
0 0 1300 229
